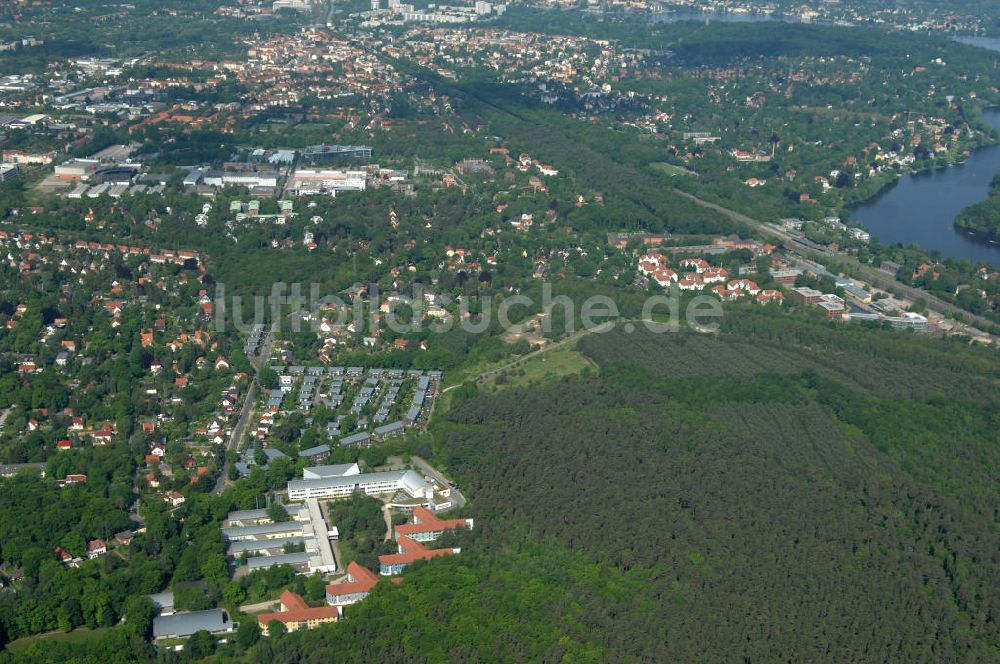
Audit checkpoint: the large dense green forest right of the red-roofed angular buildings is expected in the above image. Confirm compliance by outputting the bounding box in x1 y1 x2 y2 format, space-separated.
253 313 1000 662
